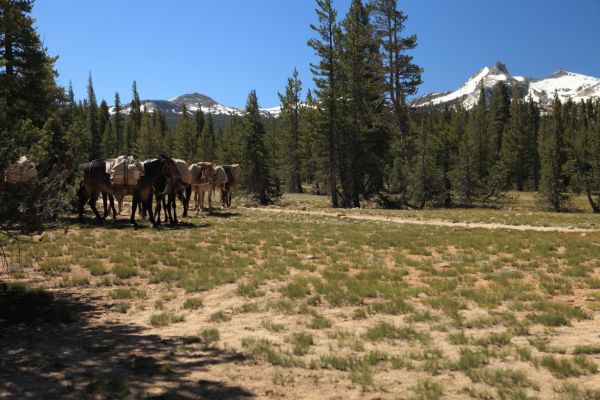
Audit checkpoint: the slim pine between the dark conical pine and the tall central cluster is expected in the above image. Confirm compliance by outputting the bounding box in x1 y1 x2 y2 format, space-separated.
278 68 303 193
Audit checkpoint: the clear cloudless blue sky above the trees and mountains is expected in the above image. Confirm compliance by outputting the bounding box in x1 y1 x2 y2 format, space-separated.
33 0 600 107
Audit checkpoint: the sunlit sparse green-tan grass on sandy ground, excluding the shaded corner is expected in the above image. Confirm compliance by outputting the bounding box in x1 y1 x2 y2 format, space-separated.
3 195 600 399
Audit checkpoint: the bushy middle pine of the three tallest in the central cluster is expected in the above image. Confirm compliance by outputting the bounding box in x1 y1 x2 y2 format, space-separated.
339 0 387 207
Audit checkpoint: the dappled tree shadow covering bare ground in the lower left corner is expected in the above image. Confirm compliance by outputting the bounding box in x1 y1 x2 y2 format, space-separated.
0 283 254 399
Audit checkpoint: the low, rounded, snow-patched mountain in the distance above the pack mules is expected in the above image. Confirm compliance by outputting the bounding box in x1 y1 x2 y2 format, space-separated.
109 93 281 127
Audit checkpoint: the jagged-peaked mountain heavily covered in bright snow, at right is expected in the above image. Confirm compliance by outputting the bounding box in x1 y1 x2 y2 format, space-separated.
412 62 600 109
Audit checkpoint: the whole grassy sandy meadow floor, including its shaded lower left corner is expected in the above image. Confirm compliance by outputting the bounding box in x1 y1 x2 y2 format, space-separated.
0 195 600 399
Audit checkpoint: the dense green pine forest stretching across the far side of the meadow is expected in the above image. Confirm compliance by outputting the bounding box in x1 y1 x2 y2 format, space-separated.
0 0 600 212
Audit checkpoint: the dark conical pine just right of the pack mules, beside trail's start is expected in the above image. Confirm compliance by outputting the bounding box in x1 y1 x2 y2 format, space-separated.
243 90 281 205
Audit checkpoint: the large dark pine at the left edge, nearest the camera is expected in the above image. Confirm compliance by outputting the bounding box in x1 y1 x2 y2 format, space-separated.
0 0 70 234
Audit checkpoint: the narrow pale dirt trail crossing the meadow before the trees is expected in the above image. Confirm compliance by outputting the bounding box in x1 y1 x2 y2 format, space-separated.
248 207 600 233
